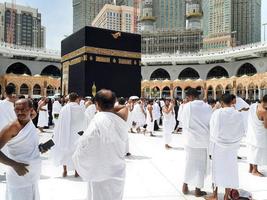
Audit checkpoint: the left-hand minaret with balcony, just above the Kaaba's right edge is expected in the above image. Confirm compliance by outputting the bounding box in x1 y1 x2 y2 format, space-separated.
141 0 156 32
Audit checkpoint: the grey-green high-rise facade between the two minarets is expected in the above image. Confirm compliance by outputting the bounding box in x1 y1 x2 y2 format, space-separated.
153 0 186 31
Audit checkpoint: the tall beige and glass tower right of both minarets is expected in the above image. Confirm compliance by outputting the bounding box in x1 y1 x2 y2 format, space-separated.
203 0 261 49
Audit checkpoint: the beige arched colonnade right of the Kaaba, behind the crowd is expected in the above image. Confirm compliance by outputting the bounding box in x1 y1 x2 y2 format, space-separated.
141 72 267 100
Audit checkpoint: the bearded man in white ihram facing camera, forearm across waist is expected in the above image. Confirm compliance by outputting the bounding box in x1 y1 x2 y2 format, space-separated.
0 99 41 200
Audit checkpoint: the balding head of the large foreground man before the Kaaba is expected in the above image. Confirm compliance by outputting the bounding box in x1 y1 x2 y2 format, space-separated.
95 89 116 111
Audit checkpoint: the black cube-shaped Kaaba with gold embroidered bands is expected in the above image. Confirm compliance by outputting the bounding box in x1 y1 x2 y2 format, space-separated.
61 26 141 97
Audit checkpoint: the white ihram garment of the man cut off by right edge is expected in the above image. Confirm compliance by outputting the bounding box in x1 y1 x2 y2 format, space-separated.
247 103 267 165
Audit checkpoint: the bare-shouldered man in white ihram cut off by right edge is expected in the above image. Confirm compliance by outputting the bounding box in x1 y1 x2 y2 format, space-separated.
247 95 267 177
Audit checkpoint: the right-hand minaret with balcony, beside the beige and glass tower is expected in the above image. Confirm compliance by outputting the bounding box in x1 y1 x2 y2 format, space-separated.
186 0 203 29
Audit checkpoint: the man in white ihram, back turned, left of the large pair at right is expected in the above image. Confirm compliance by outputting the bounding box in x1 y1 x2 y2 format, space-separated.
181 88 212 197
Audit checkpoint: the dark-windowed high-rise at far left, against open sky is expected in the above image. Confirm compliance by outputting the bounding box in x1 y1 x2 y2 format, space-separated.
0 3 45 48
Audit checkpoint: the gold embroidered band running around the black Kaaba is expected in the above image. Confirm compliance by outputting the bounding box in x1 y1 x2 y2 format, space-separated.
61 46 141 62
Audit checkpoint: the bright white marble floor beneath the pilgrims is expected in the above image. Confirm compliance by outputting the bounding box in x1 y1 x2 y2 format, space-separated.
0 132 267 200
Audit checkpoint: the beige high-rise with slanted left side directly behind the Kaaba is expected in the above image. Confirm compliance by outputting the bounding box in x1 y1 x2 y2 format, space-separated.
92 4 140 33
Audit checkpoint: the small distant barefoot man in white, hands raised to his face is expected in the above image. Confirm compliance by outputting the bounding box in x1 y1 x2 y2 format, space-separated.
162 99 176 149
